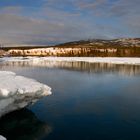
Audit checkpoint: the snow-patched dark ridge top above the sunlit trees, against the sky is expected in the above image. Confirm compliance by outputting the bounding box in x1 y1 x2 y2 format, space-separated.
0 38 140 49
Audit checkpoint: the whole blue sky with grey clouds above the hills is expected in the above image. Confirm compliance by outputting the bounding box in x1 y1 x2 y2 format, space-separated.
0 0 140 45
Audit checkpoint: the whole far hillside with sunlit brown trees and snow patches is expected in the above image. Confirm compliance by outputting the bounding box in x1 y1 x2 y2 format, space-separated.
0 38 140 57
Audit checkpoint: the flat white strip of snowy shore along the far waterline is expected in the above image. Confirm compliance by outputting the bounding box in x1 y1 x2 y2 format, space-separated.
0 57 140 65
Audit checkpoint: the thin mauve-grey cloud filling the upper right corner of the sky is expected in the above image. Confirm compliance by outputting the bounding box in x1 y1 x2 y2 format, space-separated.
75 0 140 37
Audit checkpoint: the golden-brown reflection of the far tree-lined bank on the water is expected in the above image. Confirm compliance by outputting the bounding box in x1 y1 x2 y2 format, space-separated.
0 59 140 76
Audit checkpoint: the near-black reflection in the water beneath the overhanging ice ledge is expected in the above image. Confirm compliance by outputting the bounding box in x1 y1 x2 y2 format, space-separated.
0 109 52 140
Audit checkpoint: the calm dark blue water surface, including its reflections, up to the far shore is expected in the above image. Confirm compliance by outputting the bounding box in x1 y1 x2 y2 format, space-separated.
0 62 140 140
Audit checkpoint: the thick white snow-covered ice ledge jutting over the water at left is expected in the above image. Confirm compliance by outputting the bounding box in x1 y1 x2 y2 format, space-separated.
0 71 51 117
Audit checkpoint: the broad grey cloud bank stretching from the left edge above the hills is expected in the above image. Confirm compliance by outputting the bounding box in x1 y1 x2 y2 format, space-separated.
0 4 111 44
